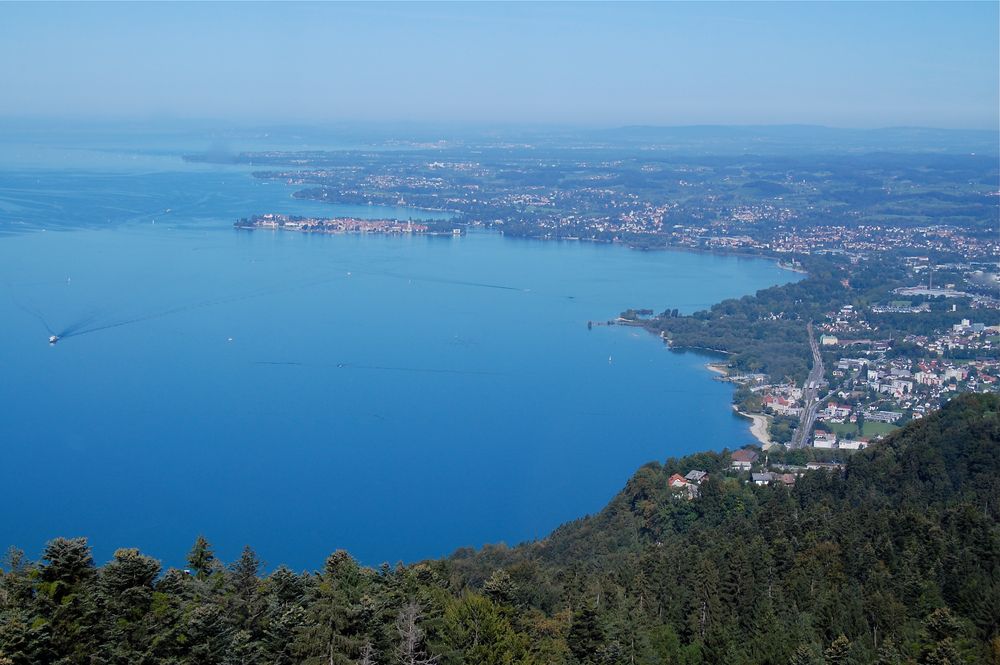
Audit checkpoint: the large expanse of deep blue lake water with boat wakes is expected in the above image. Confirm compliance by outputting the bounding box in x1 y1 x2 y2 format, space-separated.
0 139 794 568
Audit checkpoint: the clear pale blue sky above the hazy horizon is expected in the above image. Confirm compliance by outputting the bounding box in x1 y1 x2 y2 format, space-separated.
0 2 1000 129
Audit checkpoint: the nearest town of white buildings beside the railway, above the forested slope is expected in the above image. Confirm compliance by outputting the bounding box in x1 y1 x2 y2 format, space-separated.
748 302 1000 450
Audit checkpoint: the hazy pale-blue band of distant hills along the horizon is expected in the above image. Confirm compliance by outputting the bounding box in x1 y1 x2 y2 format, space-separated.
0 119 1000 154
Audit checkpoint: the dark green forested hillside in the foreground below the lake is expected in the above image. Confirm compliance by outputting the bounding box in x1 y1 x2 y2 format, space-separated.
0 395 1000 665
